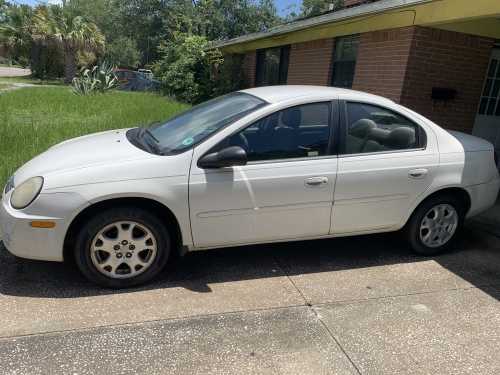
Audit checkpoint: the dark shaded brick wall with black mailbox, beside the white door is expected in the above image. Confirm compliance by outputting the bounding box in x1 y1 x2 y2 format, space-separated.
400 27 494 132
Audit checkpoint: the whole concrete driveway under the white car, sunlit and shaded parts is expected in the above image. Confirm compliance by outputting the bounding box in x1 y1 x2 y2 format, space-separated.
0 225 500 375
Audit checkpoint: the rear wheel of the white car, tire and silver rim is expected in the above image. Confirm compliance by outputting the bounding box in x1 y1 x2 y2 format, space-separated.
406 195 466 256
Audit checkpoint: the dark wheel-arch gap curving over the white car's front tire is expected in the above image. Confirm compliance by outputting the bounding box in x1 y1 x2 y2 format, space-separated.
64 197 182 261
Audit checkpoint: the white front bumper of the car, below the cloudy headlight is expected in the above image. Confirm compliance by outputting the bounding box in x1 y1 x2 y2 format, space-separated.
0 193 86 262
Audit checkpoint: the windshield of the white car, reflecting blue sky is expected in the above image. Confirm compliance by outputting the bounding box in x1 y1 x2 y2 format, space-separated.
148 92 266 154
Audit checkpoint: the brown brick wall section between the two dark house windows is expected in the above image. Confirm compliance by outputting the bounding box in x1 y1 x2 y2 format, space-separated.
287 39 334 86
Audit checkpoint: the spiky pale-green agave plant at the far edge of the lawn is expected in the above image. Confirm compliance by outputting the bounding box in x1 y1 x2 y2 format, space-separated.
73 62 119 95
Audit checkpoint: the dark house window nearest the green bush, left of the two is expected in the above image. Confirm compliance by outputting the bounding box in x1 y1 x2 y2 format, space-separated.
255 46 290 86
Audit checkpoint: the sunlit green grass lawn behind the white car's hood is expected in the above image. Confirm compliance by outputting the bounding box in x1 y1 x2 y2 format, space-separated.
0 87 188 187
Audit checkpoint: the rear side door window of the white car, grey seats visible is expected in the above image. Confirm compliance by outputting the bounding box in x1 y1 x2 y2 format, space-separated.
345 103 423 154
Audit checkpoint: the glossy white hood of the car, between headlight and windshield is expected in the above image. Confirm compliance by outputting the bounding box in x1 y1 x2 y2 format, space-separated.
14 130 153 185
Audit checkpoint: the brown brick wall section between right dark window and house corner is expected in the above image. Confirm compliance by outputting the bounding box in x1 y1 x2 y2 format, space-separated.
353 27 413 101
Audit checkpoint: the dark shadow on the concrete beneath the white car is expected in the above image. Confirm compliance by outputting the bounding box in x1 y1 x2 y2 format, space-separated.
0 228 500 299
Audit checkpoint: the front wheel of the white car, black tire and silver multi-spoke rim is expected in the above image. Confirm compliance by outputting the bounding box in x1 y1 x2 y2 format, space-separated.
75 207 171 288
